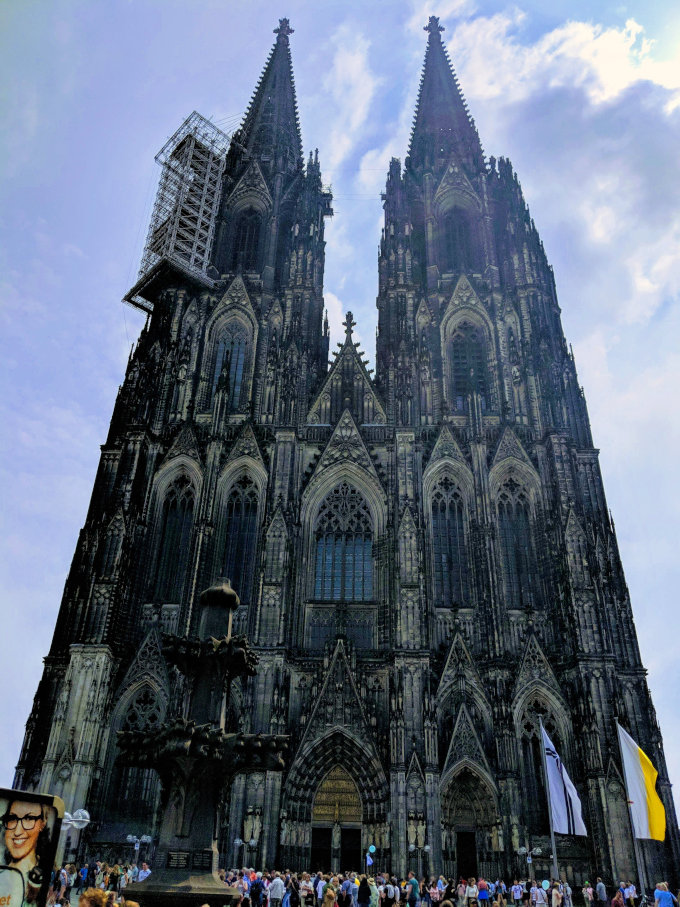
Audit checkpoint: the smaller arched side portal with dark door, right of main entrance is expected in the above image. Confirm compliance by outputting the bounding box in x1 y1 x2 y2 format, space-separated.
442 764 503 879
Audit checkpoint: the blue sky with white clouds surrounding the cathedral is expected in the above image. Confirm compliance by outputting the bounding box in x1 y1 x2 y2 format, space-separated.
0 0 680 820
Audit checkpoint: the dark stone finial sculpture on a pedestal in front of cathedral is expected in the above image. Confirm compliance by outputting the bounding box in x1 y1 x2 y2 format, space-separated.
118 583 288 907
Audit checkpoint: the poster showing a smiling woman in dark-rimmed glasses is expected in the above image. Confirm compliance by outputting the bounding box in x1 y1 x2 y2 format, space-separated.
0 788 64 907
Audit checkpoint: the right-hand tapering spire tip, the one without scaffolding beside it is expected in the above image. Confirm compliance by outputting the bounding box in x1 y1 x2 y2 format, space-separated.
409 16 484 172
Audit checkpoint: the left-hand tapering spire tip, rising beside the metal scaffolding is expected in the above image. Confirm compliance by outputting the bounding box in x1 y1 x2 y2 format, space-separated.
239 19 302 167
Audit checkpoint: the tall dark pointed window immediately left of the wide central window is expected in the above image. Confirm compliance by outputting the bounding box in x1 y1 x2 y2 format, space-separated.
217 476 258 605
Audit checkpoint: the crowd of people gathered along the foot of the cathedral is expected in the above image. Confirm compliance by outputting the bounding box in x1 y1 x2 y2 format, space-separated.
48 860 679 907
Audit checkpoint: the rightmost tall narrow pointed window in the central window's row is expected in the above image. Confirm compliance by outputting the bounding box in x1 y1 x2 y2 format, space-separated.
498 478 537 608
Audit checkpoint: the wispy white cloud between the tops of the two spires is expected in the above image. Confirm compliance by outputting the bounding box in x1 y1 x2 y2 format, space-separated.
323 25 380 170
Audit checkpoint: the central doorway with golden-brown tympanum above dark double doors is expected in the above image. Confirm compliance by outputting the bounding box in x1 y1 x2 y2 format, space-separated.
311 765 362 872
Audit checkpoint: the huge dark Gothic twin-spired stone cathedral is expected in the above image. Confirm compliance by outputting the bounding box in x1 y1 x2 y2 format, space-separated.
15 17 680 885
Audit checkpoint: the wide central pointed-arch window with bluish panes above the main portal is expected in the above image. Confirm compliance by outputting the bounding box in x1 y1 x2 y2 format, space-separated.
314 482 373 601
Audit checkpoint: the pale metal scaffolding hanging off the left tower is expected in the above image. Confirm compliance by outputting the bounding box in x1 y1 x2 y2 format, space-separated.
126 111 230 311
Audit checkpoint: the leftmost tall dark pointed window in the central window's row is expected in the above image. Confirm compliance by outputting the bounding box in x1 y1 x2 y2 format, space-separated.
154 475 196 602
